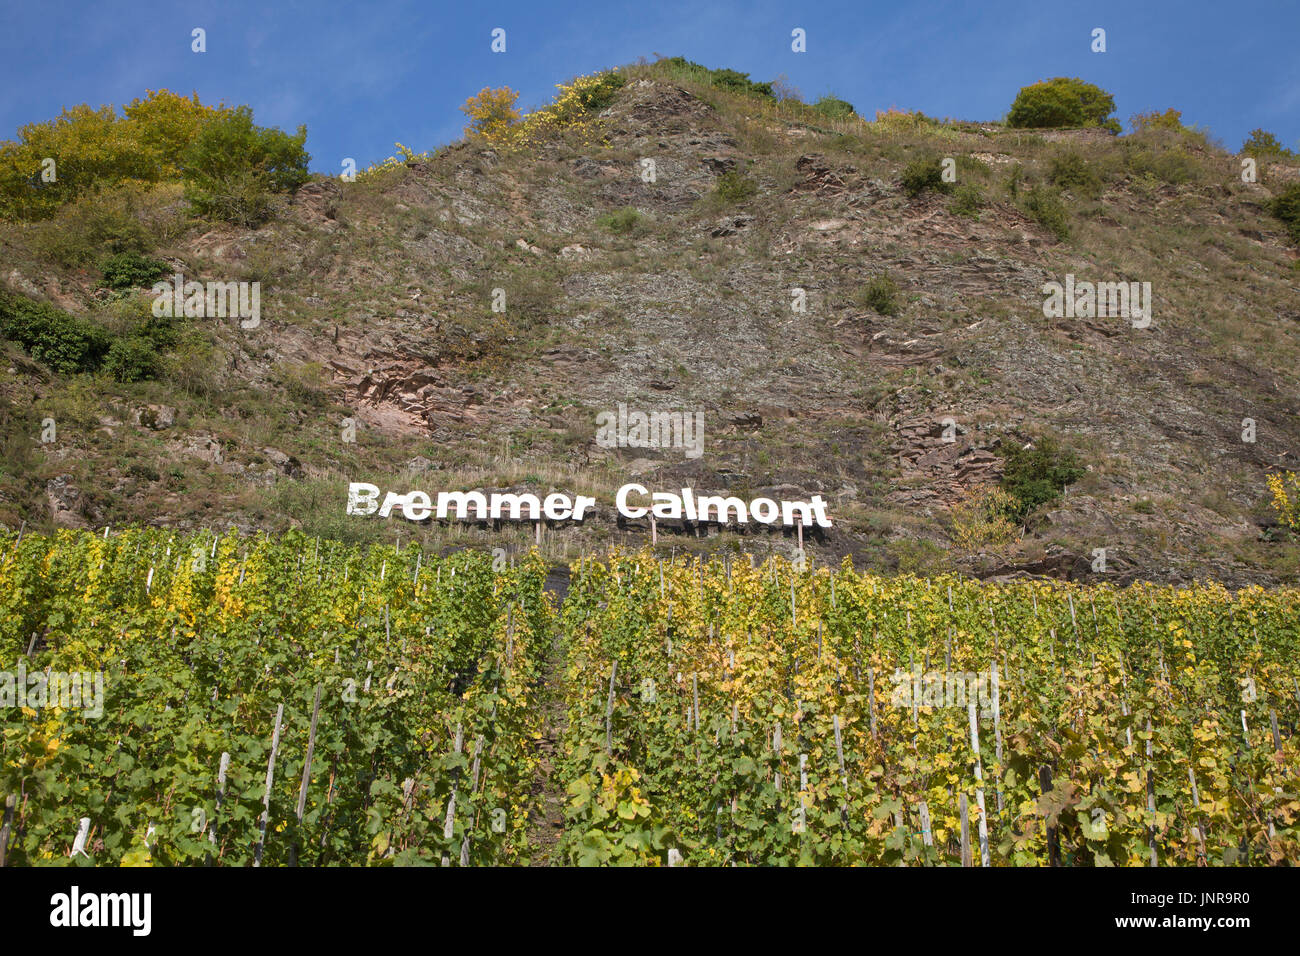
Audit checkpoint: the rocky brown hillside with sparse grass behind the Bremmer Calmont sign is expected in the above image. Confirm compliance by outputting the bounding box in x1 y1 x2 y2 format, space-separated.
0 65 1300 585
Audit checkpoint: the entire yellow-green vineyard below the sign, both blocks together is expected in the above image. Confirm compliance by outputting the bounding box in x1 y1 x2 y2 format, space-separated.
0 529 1300 866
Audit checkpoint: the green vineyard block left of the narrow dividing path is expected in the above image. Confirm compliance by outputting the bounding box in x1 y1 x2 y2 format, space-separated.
0 531 551 866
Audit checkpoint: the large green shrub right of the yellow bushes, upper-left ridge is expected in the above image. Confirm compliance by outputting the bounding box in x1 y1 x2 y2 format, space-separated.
183 107 311 226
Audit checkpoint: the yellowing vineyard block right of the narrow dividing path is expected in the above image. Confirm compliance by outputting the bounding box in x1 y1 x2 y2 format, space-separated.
563 554 1300 866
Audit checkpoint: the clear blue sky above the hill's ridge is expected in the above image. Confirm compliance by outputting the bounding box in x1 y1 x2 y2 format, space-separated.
0 0 1300 172
